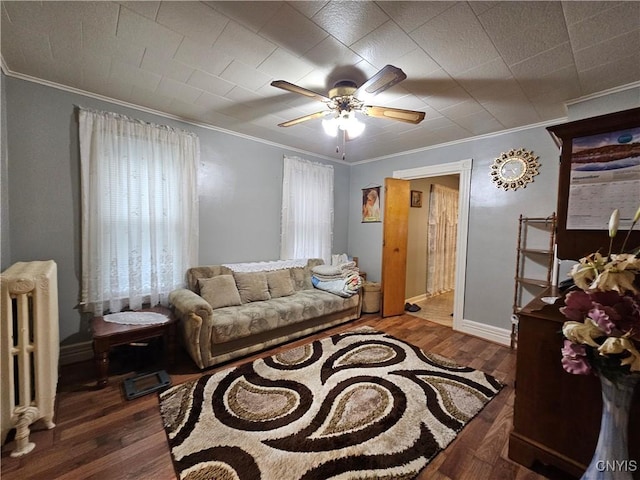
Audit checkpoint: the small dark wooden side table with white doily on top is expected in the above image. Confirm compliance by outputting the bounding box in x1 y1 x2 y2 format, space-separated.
91 307 178 388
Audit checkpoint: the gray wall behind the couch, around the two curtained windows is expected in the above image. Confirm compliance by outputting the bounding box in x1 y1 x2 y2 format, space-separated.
2 77 349 344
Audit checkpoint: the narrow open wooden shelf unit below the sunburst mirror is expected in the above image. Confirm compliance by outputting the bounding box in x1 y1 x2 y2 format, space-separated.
511 212 557 348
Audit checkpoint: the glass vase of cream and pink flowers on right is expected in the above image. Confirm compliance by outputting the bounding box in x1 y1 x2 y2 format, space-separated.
560 208 640 480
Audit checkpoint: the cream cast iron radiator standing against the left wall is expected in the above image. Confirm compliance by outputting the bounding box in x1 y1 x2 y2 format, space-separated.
0 260 60 457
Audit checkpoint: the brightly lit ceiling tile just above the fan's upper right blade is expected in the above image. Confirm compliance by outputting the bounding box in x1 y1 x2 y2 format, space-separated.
351 21 418 68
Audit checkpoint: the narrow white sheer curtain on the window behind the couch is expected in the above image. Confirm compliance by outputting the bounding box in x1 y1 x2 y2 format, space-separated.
280 156 333 264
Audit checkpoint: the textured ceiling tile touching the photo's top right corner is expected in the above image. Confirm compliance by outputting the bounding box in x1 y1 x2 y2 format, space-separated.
569 2 640 50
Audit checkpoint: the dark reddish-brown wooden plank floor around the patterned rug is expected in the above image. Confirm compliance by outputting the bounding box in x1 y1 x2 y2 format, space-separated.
0 314 570 480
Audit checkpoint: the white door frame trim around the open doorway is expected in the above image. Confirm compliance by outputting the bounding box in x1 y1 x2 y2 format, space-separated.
393 159 473 330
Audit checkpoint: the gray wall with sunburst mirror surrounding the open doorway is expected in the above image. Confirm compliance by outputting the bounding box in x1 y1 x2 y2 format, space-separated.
349 88 640 330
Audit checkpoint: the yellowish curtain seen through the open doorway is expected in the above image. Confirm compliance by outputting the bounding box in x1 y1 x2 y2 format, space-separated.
427 184 458 295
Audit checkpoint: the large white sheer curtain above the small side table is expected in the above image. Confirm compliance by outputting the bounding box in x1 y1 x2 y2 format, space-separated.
79 109 200 315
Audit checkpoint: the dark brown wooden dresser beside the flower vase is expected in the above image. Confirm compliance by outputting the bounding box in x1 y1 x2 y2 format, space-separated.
509 289 640 479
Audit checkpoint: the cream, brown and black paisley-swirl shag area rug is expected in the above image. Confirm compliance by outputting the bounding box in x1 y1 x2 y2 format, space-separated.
160 327 502 480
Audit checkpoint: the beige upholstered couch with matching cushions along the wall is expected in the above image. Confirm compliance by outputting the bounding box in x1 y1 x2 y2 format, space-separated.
169 259 361 369
